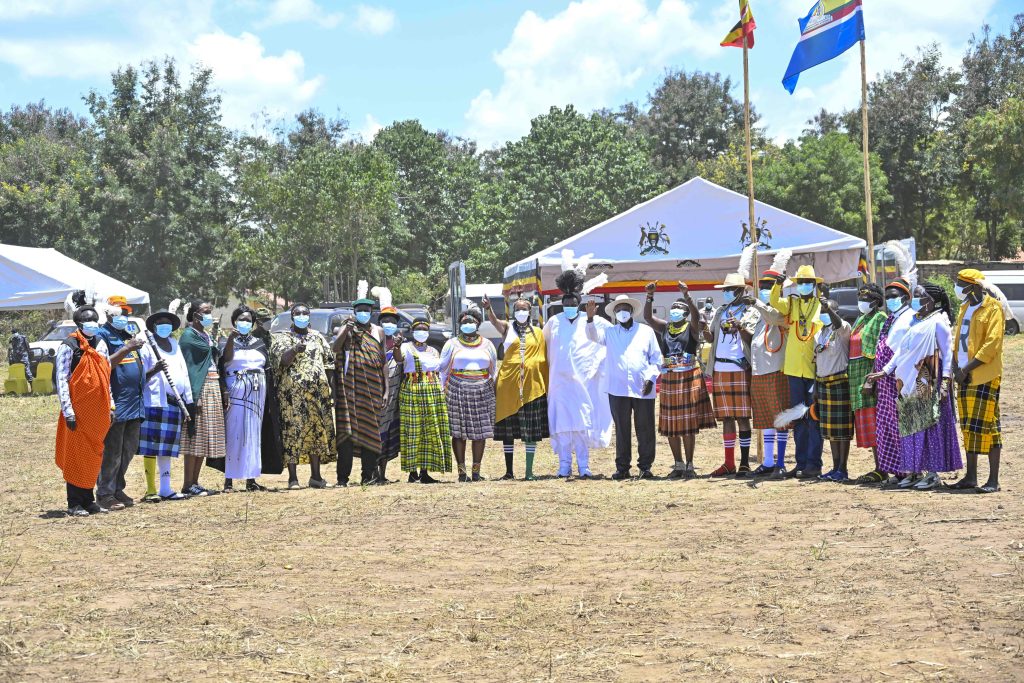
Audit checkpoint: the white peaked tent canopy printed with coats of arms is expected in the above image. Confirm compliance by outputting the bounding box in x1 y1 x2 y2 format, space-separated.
504 177 866 295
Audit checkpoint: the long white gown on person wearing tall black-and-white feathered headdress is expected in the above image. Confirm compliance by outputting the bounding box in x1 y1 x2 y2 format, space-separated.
544 311 612 449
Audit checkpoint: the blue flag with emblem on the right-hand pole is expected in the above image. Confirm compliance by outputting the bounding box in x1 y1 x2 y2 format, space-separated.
782 0 864 95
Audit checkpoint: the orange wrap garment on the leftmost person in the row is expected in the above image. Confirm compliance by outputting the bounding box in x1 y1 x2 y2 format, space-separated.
54 332 111 488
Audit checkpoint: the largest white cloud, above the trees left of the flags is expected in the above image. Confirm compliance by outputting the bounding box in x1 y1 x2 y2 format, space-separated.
465 0 720 146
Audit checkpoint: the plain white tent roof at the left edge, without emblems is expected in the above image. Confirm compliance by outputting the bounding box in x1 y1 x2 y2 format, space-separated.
0 245 150 310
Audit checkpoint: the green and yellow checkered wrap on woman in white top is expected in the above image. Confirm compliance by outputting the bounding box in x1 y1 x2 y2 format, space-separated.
398 373 452 472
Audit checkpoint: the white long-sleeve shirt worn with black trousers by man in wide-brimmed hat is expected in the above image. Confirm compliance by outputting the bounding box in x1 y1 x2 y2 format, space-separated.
587 321 662 399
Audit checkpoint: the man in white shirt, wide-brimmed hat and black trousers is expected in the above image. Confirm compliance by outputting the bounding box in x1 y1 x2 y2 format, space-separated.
587 294 662 480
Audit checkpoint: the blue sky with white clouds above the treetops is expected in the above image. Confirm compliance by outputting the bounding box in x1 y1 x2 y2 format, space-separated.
0 0 1024 146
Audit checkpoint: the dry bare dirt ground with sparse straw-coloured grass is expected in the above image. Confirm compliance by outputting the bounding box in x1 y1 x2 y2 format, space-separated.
0 340 1024 682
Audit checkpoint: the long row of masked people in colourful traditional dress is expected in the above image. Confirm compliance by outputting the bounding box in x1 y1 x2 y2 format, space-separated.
56 253 1004 516
